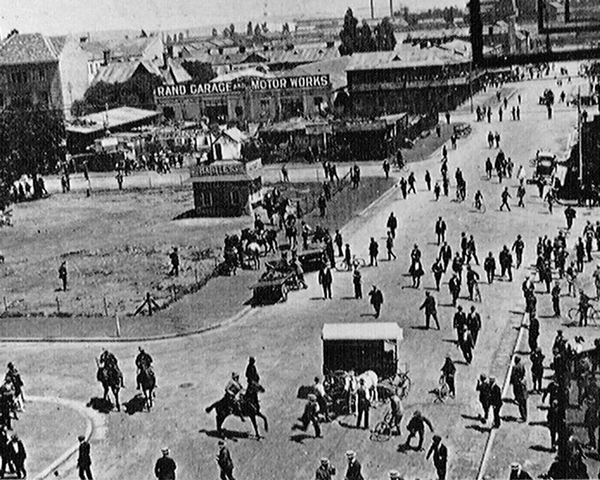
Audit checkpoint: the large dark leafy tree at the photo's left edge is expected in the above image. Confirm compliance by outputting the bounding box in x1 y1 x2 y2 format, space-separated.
0 107 65 204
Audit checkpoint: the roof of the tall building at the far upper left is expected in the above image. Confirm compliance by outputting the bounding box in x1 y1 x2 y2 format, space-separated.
0 33 59 65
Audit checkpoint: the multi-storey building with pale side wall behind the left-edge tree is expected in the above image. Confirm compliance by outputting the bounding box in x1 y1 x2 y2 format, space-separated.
0 33 88 117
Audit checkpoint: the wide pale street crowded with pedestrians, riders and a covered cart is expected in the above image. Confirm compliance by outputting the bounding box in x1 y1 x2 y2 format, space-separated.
3 64 598 479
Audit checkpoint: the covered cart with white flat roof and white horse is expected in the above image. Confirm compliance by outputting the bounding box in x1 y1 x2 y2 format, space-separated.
321 322 410 413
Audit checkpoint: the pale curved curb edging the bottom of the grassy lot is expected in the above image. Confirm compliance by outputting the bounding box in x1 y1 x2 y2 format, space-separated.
0 305 252 344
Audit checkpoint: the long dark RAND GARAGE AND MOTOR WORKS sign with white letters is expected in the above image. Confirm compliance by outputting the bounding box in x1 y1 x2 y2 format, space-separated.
154 75 330 98
